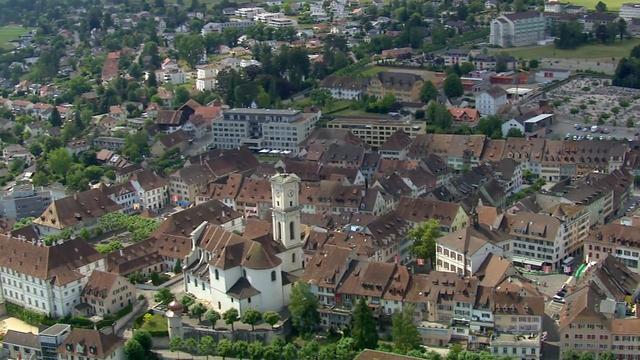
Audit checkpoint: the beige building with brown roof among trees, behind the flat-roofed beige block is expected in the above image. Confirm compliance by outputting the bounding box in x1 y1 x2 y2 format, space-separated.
367 71 424 103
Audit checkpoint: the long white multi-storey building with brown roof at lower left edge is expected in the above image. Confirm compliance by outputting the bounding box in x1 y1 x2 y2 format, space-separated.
0 235 105 317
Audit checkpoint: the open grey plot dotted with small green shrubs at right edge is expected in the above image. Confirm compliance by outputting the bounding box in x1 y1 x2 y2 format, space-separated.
549 78 640 140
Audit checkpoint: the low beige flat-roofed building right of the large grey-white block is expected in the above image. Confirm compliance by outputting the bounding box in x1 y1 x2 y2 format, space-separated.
327 116 426 149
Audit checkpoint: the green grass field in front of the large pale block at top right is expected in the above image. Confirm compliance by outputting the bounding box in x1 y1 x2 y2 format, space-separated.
491 39 640 59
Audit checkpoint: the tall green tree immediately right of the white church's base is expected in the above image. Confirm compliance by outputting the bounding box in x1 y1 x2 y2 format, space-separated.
289 282 320 335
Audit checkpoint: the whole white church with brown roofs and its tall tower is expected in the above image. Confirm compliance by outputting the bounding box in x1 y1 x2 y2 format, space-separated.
184 173 304 315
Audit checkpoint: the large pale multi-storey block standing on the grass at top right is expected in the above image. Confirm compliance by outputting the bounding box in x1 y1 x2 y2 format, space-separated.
489 11 546 47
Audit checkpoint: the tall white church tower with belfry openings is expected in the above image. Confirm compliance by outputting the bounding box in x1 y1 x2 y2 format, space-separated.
271 173 304 272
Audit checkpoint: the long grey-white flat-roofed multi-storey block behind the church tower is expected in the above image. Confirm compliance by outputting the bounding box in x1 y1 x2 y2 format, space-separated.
212 108 321 154
